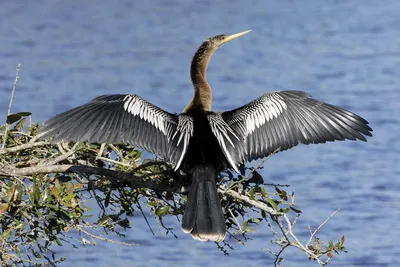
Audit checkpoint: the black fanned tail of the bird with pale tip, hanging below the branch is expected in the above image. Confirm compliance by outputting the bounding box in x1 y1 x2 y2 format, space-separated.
182 165 226 242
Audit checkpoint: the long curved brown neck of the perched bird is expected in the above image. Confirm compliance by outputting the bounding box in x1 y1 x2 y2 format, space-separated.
184 41 215 112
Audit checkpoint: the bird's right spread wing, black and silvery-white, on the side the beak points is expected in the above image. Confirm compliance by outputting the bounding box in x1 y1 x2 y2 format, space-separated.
209 91 372 170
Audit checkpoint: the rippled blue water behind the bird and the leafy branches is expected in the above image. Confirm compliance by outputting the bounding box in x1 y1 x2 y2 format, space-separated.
0 0 400 267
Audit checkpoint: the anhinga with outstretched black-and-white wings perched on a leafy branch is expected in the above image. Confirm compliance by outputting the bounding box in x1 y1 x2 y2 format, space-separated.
41 31 372 244
